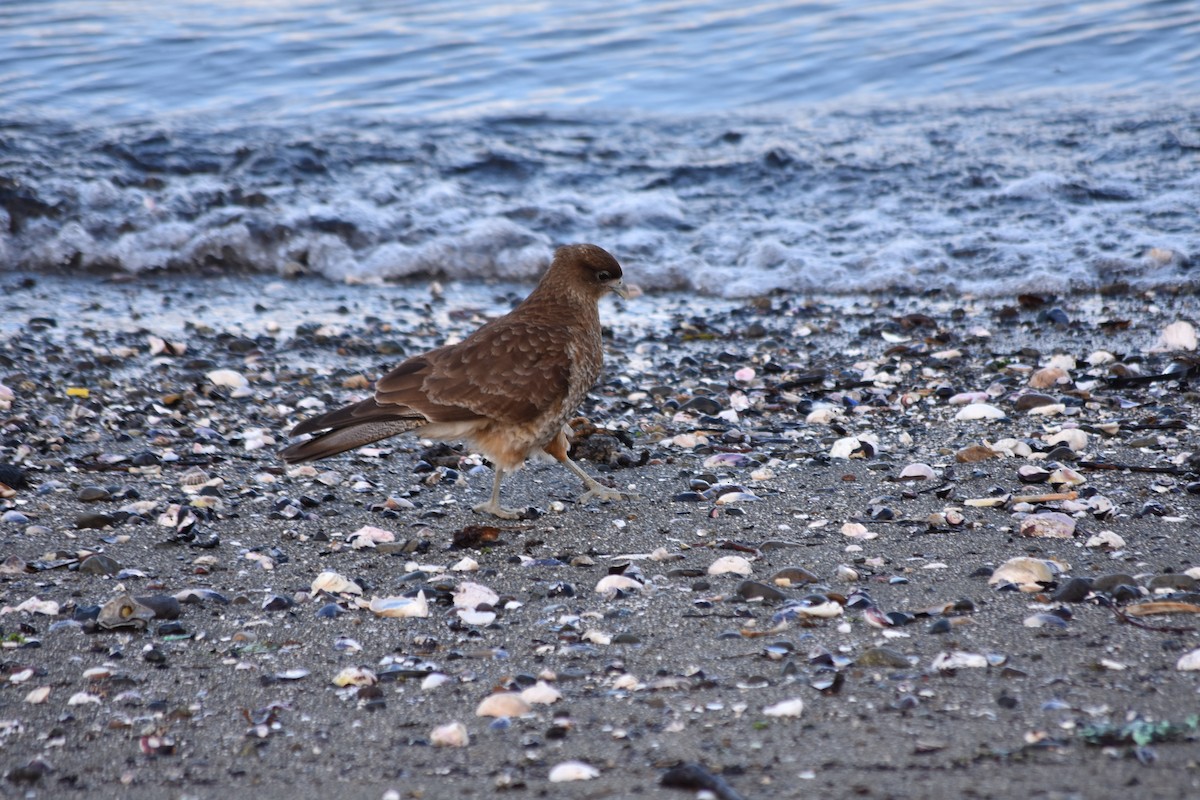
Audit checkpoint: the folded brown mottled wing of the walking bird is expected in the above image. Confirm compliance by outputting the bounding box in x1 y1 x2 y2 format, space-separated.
374 317 571 423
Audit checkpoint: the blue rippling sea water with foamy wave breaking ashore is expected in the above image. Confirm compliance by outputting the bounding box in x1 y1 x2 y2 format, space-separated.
0 0 1200 296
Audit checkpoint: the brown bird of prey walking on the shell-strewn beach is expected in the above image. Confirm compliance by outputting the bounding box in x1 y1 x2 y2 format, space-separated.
281 245 626 519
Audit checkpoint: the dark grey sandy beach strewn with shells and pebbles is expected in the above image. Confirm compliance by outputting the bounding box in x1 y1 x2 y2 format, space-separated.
0 273 1200 800
